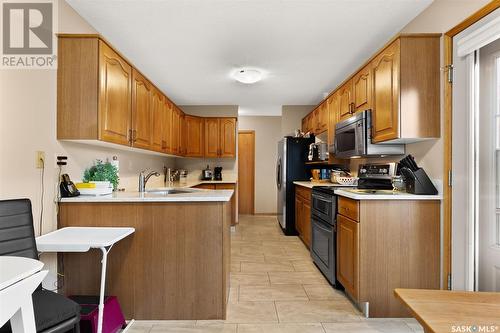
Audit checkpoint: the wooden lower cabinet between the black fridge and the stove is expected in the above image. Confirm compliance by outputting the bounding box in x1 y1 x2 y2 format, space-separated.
295 185 311 248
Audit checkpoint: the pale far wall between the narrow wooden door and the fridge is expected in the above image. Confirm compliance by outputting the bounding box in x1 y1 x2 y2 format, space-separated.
239 116 282 214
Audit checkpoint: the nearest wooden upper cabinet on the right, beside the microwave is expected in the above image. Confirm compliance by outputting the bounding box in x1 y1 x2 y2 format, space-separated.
371 34 440 143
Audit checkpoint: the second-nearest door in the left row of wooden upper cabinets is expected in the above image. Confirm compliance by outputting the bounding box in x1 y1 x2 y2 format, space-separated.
131 69 153 149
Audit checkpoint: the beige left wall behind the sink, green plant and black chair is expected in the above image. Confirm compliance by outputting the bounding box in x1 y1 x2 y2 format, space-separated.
0 0 173 288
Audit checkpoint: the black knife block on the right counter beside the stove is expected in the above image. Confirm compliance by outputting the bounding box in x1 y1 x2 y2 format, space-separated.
399 155 438 195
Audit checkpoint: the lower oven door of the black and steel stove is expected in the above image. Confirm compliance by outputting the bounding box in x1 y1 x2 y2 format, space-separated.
311 215 336 285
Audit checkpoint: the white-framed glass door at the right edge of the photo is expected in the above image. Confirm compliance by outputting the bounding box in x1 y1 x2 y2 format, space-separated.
477 40 500 292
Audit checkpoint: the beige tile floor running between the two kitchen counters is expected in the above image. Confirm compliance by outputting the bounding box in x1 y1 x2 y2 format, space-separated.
128 216 423 333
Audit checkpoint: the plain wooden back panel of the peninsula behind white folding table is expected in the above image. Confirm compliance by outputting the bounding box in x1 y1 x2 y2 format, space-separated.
58 202 231 320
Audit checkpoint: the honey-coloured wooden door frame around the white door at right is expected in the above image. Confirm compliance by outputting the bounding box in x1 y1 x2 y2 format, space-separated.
442 0 500 289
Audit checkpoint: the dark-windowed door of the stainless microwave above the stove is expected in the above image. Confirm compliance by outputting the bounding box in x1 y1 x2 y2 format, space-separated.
333 118 366 158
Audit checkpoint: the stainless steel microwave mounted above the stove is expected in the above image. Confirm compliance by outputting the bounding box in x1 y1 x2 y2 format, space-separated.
329 110 405 158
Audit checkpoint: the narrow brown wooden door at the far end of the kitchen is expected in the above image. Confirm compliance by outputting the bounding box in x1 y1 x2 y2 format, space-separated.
238 131 255 214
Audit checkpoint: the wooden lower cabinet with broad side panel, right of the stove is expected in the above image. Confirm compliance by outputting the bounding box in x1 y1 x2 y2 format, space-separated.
337 198 440 318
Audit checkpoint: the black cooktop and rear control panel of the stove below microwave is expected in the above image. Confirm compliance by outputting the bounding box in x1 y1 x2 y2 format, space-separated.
358 162 396 190
